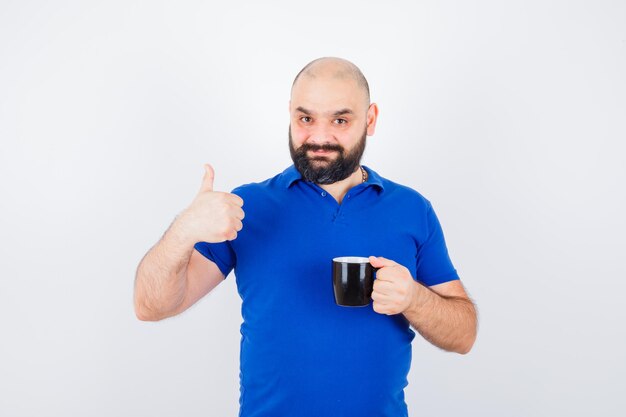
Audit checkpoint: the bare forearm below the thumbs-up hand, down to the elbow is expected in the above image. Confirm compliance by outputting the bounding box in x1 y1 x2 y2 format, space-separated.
134 216 195 320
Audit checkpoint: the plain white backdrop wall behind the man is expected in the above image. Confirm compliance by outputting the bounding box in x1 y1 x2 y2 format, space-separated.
0 0 626 417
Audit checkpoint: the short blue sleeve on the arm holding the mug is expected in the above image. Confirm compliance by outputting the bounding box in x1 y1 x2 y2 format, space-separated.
416 202 459 286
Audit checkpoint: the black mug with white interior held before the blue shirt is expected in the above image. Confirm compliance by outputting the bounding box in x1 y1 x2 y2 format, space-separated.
333 256 378 307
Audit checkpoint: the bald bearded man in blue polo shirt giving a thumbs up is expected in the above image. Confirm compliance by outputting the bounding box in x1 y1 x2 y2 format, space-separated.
135 58 477 417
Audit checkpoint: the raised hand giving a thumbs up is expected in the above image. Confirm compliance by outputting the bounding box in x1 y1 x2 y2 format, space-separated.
179 164 244 243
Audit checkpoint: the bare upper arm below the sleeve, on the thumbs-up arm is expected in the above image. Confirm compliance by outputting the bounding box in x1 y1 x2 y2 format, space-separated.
174 249 225 314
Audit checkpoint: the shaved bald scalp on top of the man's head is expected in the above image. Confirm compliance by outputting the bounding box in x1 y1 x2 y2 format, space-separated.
291 57 370 106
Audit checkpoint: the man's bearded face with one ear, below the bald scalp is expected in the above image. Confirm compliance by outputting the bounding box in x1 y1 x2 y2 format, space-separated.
289 76 378 184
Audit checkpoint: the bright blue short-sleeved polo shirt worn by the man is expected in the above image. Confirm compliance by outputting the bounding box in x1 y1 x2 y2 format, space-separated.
195 165 458 417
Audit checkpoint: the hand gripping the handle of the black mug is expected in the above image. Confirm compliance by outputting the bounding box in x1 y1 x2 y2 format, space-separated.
369 256 418 315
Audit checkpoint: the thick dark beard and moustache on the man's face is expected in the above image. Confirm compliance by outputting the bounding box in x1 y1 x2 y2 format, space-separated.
289 125 367 184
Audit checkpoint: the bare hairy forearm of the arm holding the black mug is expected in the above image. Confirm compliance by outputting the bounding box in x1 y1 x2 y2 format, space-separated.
403 281 477 354
